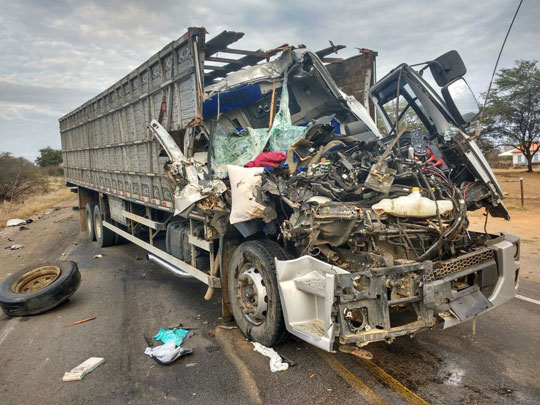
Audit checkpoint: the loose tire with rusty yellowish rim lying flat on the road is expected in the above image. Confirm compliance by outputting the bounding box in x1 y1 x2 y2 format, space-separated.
0 261 81 316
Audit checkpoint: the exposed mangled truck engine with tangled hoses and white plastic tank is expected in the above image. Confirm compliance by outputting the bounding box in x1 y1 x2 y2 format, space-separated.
262 119 494 271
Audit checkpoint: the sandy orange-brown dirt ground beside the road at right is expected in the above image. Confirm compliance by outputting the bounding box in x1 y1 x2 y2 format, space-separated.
469 169 540 283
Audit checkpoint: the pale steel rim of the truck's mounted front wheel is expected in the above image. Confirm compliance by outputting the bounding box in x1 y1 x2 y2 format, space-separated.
236 264 268 325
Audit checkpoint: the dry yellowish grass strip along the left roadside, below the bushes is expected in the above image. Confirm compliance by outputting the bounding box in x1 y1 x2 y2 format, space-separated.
0 177 75 229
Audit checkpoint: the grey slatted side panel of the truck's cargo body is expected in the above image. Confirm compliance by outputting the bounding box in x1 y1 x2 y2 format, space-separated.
60 28 205 210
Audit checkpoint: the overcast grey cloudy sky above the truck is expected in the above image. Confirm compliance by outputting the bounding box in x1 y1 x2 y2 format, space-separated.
0 0 540 160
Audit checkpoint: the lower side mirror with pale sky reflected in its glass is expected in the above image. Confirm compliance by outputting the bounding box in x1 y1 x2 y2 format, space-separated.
441 78 480 125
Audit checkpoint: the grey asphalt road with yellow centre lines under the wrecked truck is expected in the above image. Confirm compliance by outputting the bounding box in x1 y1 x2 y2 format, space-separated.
0 202 540 404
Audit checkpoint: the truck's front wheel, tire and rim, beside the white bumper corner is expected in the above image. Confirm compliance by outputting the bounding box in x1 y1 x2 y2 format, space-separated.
228 240 287 346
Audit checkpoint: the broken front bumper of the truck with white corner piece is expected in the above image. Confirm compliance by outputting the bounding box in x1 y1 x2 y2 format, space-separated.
276 234 520 351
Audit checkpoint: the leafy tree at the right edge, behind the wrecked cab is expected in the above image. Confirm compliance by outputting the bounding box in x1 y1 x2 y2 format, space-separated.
483 60 540 172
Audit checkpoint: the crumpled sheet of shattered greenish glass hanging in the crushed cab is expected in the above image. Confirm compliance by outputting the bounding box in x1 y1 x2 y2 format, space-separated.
211 80 307 179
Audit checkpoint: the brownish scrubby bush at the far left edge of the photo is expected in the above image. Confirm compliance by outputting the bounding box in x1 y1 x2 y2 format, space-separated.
0 152 48 201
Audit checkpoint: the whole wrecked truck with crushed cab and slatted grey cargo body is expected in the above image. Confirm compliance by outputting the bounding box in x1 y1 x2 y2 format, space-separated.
60 28 519 351
